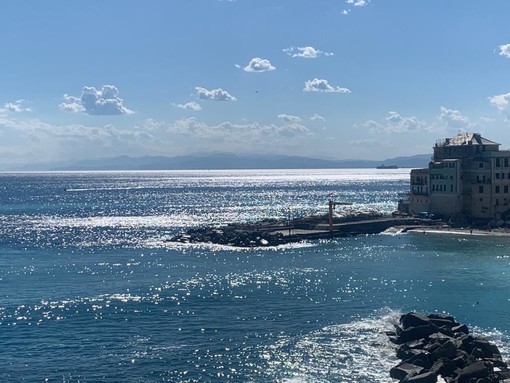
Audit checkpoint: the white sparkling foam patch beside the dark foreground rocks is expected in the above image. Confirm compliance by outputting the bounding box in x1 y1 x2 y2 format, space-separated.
264 309 400 383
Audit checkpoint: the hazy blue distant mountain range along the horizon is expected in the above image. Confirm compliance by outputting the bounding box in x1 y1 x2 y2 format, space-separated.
35 153 431 170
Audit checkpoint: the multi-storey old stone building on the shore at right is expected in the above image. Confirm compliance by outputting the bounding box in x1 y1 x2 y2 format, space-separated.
409 133 510 221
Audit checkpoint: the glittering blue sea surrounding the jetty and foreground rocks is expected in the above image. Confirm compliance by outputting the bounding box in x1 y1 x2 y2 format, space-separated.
0 169 510 383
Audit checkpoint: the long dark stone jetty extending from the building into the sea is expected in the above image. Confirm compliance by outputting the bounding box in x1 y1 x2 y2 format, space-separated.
170 214 421 247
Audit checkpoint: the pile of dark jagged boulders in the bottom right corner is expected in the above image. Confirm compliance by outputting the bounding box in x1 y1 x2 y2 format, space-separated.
388 313 510 383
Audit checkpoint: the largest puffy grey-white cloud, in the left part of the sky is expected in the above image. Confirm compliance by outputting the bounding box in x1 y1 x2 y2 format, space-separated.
59 85 134 116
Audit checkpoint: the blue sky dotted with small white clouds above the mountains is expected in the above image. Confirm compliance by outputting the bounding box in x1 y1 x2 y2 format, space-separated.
0 0 510 170
